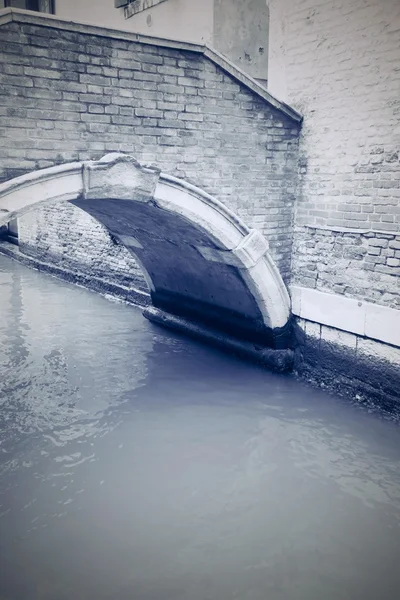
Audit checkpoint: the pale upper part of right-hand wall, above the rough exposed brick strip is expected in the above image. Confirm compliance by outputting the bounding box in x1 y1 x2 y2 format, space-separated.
269 0 400 232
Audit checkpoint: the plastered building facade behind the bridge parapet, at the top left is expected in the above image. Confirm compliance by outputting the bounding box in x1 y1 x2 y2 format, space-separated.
0 0 269 82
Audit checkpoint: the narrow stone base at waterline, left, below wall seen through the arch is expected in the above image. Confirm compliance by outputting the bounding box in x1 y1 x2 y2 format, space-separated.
0 241 151 306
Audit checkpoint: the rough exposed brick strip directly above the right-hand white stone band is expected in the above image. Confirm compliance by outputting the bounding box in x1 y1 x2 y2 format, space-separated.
292 227 400 309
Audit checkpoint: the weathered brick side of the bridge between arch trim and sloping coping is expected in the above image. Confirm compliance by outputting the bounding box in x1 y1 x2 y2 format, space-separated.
0 15 298 284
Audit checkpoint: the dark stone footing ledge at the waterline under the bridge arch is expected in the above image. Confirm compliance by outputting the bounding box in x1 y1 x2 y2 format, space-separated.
143 306 293 373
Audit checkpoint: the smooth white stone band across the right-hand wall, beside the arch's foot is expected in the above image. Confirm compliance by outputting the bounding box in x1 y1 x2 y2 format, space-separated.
290 285 400 347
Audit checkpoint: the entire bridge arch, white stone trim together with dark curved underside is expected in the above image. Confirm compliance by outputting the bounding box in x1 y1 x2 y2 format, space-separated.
0 154 290 348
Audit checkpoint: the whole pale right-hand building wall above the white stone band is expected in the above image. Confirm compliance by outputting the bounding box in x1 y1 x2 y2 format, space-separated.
269 0 400 308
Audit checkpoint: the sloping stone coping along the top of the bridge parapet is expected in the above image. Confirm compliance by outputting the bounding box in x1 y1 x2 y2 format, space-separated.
0 8 303 123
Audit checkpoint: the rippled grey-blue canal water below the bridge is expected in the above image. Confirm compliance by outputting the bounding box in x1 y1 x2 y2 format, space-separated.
0 256 400 600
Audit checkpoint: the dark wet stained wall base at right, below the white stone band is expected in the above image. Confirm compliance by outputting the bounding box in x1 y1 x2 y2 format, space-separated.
293 328 400 420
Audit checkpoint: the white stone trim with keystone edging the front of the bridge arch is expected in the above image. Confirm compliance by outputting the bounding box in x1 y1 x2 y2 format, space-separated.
0 153 290 329
